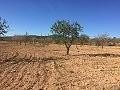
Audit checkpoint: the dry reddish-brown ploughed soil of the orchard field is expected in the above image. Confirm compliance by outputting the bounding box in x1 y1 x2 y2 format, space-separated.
0 43 120 90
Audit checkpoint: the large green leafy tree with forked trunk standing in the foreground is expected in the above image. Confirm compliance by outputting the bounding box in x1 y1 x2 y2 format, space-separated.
51 20 83 55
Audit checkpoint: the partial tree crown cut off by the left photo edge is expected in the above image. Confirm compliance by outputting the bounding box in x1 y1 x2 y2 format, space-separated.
0 17 9 36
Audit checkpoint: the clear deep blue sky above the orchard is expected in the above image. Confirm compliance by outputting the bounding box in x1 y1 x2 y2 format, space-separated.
0 0 120 37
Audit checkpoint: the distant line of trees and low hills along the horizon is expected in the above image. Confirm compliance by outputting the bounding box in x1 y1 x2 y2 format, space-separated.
0 34 120 46
